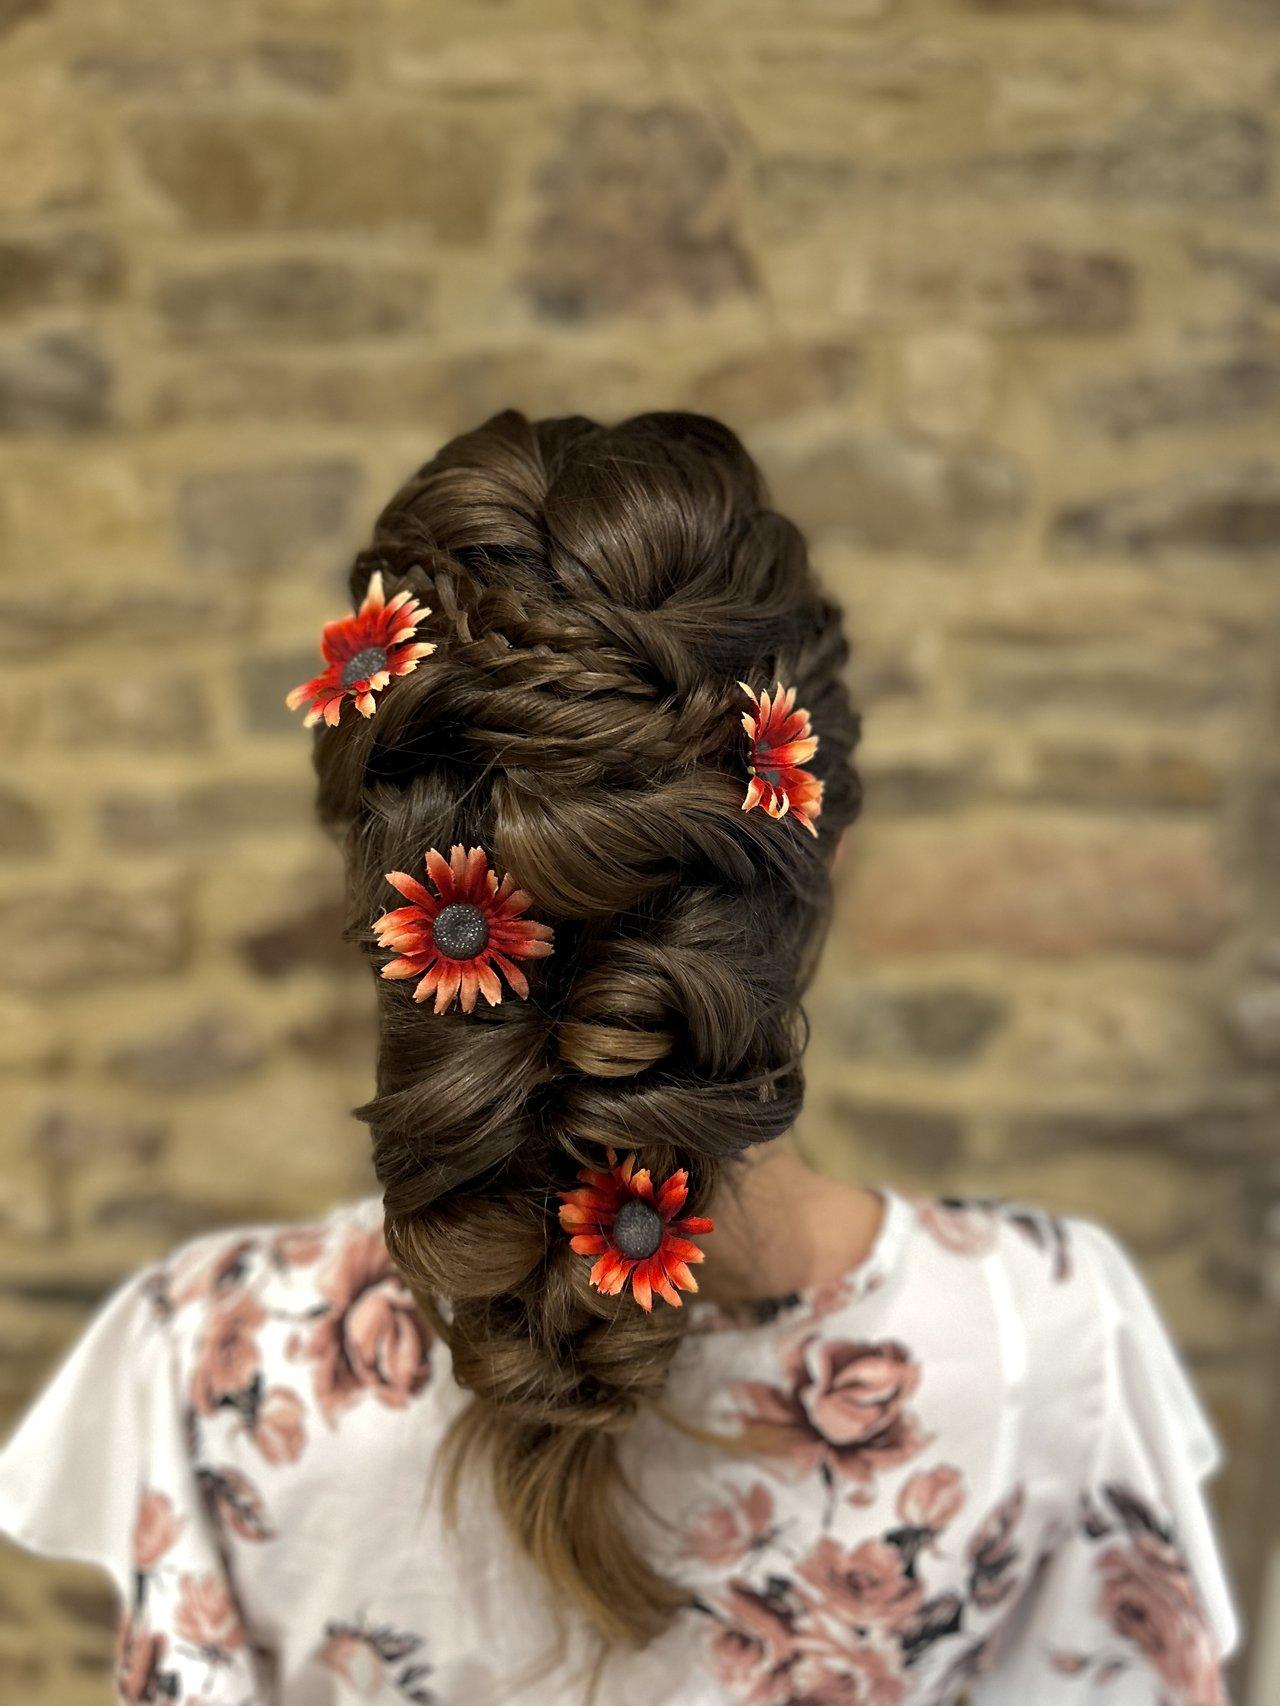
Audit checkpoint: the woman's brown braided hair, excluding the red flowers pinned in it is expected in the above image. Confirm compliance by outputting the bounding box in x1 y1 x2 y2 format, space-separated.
316 411 860 1645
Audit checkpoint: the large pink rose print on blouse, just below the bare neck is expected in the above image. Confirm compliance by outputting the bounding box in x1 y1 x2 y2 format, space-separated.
736 1336 925 1498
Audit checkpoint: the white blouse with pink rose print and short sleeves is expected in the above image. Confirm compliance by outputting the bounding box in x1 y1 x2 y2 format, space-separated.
0 1191 1236 1706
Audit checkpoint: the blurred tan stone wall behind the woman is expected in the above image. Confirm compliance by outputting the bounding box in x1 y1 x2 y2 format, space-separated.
0 0 1280 1706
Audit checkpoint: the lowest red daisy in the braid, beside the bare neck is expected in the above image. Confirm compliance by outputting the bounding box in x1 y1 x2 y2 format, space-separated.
560 1150 715 1310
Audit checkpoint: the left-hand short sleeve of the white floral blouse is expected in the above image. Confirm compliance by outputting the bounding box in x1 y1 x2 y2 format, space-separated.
0 1271 270 1706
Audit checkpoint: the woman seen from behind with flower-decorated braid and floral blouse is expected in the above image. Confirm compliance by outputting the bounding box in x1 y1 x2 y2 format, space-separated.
0 413 1234 1706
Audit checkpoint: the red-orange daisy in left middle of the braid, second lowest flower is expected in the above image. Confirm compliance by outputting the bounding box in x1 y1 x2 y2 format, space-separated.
374 846 551 1013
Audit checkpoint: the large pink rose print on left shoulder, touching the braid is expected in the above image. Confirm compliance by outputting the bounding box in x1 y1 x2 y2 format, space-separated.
305 1230 430 1423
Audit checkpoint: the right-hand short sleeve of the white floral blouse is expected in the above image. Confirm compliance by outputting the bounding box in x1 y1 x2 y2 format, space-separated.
973 1223 1239 1706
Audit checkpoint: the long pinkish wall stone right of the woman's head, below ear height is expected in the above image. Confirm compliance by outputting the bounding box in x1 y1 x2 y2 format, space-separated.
850 824 1234 959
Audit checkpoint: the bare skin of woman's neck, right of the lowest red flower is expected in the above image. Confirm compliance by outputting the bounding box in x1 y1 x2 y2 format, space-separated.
698 1140 884 1303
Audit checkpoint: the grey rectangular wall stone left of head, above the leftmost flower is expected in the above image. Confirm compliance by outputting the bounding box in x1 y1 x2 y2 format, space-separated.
176 457 360 573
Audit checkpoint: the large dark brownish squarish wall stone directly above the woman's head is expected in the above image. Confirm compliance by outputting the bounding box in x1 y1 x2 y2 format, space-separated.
524 102 754 321
